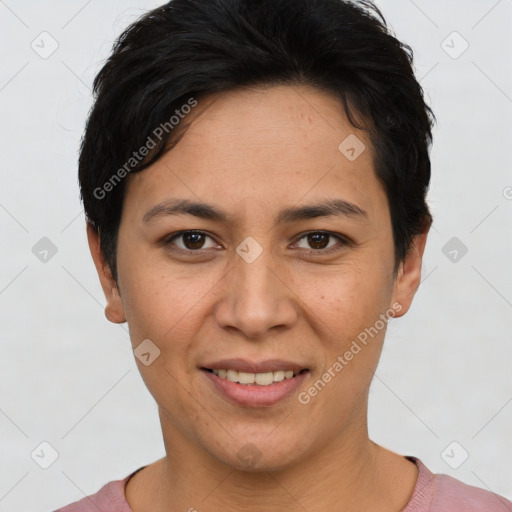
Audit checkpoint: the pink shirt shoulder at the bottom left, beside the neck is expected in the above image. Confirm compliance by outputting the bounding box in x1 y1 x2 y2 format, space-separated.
55 468 143 512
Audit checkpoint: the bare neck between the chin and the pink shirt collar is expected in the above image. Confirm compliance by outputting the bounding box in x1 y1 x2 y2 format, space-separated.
127 402 417 512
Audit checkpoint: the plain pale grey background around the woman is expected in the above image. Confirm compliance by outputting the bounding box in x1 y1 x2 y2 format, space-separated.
0 0 512 512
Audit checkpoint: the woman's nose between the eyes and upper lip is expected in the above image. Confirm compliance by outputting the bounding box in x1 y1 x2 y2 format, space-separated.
215 239 299 340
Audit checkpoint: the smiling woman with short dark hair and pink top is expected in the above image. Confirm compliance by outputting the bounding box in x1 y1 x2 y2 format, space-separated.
54 0 512 512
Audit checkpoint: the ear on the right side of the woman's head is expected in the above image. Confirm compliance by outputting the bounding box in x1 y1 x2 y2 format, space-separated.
392 226 430 317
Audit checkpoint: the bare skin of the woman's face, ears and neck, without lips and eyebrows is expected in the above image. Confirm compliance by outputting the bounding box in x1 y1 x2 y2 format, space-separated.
88 86 427 512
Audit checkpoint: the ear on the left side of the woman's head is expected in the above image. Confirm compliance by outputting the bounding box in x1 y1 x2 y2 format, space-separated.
87 222 126 324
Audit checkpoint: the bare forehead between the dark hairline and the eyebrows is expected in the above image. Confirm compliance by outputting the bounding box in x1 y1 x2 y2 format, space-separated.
125 86 386 223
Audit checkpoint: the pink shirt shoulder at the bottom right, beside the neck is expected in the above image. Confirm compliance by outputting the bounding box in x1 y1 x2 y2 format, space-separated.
404 457 512 512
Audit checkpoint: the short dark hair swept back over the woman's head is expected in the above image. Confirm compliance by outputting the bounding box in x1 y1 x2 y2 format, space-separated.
79 0 435 280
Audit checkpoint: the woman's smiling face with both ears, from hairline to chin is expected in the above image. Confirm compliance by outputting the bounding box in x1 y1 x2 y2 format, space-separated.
89 86 426 470
